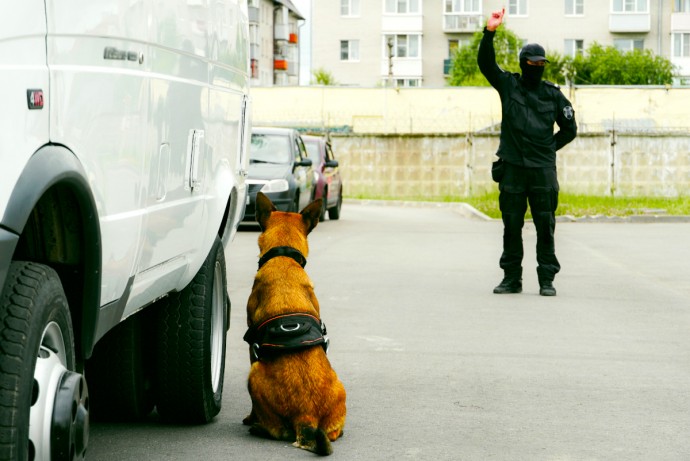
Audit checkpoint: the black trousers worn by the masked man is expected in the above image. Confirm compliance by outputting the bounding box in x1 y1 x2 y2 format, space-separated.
498 163 561 282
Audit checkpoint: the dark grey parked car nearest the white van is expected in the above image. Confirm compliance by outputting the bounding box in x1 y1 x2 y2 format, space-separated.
244 127 314 222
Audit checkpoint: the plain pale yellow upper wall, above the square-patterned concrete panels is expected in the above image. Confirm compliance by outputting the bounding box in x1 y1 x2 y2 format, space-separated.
252 86 690 134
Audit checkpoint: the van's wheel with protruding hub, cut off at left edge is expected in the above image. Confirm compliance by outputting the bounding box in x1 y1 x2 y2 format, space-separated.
0 262 89 460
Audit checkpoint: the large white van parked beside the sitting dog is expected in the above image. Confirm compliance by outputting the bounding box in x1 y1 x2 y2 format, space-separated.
0 0 250 460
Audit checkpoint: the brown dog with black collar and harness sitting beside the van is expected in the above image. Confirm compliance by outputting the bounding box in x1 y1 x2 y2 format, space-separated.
243 192 346 455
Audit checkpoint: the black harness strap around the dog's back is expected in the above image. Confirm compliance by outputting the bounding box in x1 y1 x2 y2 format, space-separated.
243 312 329 360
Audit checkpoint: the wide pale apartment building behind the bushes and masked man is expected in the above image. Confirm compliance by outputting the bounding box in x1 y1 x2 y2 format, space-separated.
308 0 690 87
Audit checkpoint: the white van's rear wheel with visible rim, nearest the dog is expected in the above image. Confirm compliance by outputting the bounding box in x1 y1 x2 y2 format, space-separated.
156 237 229 423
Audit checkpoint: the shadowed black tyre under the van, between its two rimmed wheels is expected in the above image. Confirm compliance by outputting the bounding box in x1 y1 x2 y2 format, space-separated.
86 309 154 421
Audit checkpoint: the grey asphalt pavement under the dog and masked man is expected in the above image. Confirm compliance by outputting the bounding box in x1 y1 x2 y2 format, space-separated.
88 204 690 461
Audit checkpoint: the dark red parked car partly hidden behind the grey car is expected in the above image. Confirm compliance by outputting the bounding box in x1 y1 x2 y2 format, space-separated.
302 135 343 220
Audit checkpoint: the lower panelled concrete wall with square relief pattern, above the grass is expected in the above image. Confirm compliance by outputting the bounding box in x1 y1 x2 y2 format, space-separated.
332 133 690 200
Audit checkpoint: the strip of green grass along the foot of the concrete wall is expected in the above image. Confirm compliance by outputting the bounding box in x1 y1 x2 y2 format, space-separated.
352 191 690 219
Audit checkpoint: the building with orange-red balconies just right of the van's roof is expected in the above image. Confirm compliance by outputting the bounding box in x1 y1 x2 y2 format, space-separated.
248 0 304 86
